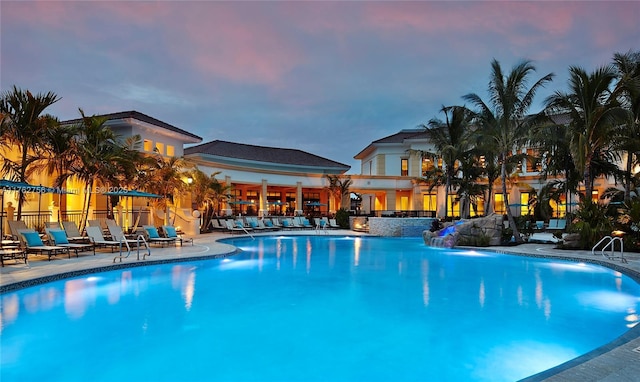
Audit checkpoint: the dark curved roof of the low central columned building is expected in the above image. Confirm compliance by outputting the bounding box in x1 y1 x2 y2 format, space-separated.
184 140 351 171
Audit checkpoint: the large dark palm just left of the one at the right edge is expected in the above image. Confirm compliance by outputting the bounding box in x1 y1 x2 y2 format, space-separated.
545 66 627 198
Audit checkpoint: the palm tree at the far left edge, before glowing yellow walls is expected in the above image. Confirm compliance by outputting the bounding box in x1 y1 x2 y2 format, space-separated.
0 85 59 220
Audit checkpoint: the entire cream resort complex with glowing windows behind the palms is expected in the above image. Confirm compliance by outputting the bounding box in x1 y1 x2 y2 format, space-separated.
0 111 632 234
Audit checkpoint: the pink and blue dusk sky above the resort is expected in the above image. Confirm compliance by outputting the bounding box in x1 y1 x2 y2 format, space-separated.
0 0 640 173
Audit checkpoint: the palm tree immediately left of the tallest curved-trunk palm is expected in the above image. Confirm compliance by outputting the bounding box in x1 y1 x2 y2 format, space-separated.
421 106 472 219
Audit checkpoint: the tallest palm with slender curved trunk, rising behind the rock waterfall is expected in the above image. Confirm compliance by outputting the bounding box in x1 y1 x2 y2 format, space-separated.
463 59 553 242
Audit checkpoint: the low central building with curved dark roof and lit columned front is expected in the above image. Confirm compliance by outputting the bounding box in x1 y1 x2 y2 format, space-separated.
185 140 350 216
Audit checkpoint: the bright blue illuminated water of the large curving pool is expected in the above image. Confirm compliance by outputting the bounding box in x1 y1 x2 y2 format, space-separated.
0 236 640 382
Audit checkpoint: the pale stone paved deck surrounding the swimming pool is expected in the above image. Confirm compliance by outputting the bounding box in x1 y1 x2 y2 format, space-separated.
0 230 640 382
